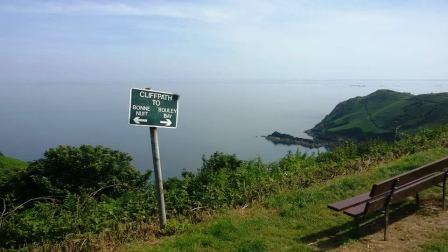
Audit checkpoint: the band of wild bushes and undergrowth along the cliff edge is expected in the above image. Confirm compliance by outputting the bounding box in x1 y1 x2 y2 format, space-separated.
0 127 448 248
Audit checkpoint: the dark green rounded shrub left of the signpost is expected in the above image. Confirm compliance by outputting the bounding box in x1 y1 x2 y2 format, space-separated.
0 145 150 202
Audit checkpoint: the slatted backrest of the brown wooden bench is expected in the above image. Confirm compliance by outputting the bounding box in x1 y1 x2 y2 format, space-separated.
370 157 448 198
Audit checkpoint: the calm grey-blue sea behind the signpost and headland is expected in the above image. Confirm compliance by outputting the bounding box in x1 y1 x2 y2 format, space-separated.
0 80 448 178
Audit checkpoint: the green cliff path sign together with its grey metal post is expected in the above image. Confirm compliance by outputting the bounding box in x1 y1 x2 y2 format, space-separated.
129 88 179 228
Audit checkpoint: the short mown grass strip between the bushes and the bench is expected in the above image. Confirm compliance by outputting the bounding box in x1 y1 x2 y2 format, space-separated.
127 148 448 251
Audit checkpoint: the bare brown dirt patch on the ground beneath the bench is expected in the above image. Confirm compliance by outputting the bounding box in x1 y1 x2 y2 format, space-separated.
334 202 448 251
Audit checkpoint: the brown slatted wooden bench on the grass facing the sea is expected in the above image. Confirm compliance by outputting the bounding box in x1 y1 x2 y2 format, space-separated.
328 157 448 240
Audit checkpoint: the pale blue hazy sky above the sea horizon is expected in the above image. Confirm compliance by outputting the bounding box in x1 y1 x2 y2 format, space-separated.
0 0 448 84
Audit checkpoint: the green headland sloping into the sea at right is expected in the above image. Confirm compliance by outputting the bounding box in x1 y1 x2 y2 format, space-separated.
307 90 448 141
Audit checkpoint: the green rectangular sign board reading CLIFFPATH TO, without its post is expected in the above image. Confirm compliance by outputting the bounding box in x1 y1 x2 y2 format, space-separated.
129 88 179 128
